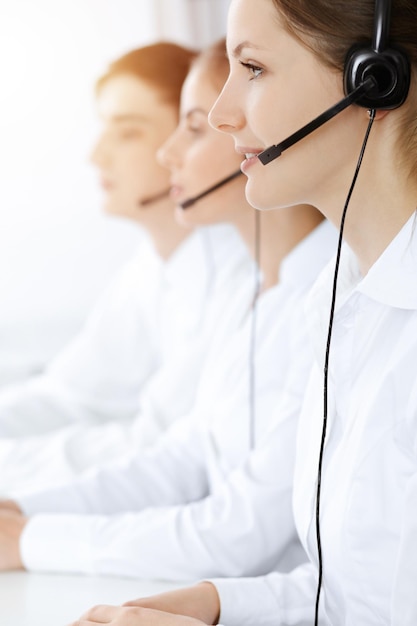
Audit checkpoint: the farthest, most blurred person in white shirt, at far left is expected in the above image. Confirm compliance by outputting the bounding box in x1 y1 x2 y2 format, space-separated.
0 42 253 494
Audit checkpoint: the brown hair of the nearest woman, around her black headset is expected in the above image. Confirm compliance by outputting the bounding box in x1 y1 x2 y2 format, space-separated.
271 0 417 178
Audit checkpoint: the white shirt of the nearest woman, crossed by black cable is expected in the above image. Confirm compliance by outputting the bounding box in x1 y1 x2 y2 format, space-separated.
211 215 417 626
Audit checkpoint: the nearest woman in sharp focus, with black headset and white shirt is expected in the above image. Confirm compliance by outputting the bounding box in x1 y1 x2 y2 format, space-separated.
63 0 417 626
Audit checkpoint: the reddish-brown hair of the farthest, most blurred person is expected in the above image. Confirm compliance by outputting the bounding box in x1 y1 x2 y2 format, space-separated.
96 42 196 106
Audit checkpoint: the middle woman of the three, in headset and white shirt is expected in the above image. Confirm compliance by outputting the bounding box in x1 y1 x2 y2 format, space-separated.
0 41 336 581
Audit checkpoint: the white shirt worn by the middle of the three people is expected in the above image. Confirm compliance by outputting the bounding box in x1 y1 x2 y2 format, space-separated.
18 223 336 580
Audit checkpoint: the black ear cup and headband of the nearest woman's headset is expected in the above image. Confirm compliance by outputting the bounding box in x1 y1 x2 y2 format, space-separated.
344 0 411 109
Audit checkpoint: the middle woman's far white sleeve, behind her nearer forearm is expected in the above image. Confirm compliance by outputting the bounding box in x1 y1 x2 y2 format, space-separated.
15 416 207 516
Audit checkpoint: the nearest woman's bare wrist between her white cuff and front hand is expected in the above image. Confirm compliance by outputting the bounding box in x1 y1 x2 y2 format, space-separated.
124 582 220 624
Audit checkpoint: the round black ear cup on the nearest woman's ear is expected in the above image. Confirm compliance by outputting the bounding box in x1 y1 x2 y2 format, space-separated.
344 46 411 109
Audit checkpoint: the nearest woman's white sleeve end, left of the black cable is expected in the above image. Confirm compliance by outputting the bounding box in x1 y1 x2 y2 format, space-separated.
211 563 317 626
